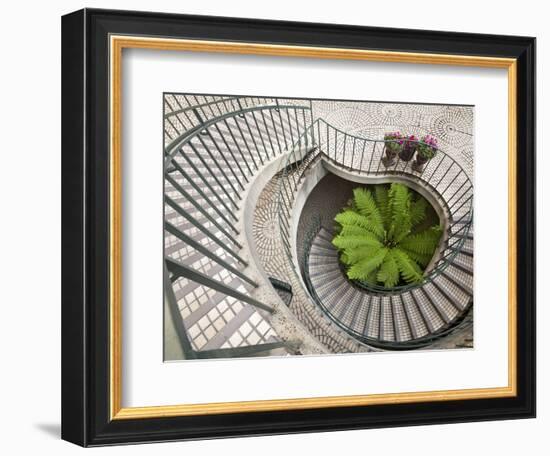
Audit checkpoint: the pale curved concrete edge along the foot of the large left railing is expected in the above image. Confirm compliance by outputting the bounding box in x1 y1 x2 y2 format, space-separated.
236 148 331 355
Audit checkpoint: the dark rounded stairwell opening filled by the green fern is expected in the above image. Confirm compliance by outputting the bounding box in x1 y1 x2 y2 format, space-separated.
296 173 445 294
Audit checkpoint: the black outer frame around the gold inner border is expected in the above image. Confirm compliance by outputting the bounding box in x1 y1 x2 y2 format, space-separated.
61 9 535 446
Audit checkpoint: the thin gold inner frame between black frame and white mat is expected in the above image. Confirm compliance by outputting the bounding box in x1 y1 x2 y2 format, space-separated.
109 35 517 419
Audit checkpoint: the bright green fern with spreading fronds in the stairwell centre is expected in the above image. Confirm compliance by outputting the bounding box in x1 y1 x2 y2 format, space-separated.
332 183 442 288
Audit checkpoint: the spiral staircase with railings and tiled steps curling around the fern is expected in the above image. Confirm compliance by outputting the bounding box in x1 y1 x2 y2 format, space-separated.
164 94 473 360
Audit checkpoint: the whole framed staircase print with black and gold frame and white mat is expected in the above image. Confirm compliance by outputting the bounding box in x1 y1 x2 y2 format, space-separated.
62 9 535 446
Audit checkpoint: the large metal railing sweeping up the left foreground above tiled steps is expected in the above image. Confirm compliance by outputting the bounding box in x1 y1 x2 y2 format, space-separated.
164 94 311 358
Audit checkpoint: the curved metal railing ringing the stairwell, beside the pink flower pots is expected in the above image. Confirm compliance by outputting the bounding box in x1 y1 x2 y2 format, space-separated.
278 119 473 346
